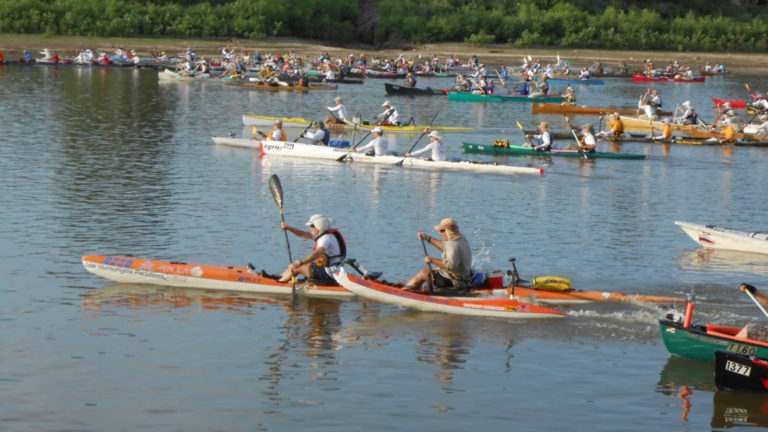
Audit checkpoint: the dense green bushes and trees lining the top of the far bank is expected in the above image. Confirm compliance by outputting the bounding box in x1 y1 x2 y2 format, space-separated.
0 0 768 52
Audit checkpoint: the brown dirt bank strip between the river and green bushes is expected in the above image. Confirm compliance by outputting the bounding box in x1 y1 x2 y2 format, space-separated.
0 34 768 75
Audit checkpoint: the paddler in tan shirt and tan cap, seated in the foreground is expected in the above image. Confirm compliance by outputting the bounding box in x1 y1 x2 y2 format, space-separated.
403 218 472 294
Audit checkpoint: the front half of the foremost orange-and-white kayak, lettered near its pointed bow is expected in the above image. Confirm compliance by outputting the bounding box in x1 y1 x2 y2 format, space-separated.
82 255 354 298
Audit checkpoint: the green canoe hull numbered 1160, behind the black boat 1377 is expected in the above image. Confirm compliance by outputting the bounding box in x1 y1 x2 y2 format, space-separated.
659 319 768 362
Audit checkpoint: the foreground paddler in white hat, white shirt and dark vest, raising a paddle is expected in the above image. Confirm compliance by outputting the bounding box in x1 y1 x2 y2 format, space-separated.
278 214 347 282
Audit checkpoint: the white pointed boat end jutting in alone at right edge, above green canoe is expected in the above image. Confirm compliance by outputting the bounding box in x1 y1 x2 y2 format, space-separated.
675 221 768 254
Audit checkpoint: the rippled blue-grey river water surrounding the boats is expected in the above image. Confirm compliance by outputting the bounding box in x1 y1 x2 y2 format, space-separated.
0 62 768 431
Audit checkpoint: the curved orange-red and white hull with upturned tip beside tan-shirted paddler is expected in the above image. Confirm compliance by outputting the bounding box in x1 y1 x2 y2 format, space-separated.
334 268 565 319
